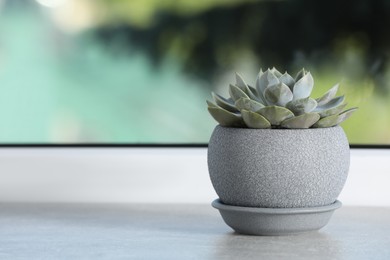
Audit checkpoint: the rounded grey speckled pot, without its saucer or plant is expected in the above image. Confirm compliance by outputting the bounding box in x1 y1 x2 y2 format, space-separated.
208 126 350 208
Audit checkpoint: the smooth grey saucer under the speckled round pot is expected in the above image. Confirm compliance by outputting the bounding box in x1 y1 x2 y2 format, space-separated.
212 199 341 236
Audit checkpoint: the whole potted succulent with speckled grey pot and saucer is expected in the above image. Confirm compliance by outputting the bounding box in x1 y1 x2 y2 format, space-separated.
207 68 357 235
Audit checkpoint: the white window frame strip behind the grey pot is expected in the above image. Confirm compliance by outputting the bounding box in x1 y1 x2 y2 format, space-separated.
0 147 390 206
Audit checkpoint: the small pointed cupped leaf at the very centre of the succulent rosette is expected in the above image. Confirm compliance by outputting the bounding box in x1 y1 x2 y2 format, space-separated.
264 83 293 107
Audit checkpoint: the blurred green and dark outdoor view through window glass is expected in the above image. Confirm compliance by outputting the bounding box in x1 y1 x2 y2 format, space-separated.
0 0 390 144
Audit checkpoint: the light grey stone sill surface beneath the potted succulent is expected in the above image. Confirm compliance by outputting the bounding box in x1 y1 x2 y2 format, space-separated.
0 203 390 260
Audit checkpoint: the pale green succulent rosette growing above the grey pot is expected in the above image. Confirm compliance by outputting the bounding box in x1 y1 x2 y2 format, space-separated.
207 68 357 129
